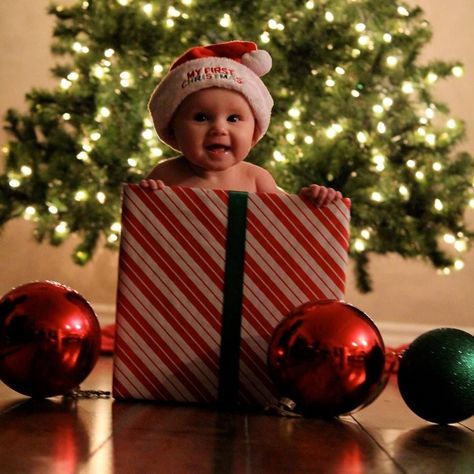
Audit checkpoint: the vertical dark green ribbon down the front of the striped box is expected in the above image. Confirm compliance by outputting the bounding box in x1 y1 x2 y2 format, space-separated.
218 191 248 406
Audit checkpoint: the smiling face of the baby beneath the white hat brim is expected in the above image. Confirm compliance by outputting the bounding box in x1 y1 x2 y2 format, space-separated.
172 88 255 171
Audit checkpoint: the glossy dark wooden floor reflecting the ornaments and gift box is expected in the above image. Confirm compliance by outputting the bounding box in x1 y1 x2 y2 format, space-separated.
0 357 474 474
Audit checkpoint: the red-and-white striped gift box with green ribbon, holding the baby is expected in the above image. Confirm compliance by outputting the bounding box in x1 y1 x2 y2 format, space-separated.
113 185 350 406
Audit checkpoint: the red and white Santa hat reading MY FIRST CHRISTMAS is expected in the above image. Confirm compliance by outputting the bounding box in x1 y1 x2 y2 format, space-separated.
148 41 273 149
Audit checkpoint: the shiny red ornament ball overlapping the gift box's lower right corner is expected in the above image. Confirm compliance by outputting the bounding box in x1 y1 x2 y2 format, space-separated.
268 300 388 418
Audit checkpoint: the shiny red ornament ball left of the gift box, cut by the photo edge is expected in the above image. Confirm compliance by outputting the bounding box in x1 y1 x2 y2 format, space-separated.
0 281 100 398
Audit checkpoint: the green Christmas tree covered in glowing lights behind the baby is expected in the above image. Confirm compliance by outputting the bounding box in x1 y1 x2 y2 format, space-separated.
0 0 474 291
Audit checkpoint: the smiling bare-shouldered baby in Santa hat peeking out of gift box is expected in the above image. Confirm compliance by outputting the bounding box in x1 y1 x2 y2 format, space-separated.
140 41 342 206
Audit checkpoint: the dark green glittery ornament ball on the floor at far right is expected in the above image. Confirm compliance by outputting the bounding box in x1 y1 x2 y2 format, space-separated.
398 328 474 424
